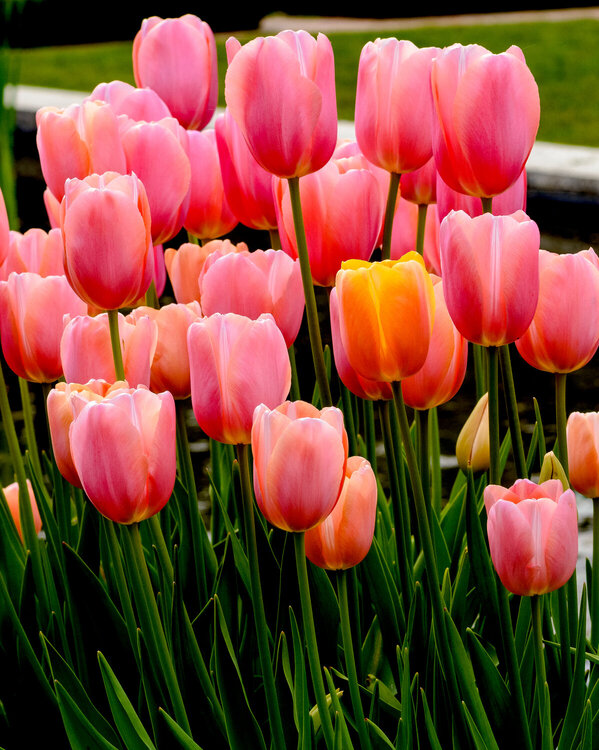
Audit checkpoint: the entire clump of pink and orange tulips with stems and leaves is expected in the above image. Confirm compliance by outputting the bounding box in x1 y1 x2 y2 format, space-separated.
0 14 599 750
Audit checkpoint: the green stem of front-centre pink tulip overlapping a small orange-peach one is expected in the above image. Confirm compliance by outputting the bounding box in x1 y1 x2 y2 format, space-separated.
293 531 335 750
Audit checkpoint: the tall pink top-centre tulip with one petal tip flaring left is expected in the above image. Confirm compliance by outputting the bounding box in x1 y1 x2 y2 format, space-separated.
225 31 337 177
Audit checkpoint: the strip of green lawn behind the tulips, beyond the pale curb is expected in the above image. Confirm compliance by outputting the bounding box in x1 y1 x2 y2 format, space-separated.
12 19 599 146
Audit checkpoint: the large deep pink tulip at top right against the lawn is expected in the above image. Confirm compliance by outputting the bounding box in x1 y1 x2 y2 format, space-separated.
431 44 540 198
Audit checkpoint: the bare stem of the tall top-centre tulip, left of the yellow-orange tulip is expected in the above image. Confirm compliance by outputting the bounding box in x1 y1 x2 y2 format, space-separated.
288 177 333 407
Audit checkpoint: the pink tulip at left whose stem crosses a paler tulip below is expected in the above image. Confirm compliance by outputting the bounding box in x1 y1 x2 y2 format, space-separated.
60 172 154 310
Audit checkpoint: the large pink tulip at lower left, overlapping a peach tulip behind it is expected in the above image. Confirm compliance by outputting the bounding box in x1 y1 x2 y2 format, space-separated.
69 387 177 524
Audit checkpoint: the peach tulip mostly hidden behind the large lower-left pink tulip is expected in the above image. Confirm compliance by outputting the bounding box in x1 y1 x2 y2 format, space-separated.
46 380 129 487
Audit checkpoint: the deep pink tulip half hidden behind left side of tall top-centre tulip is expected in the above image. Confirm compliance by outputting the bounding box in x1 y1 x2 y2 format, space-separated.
214 110 277 230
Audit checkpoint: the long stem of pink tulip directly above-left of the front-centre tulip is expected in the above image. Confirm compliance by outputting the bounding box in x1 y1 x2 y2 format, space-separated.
237 444 286 750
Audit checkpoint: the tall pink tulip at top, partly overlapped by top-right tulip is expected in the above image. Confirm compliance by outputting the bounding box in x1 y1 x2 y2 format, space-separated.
355 38 439 174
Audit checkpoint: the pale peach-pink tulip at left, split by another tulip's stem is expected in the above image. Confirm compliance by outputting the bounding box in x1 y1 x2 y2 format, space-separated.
60 313 158 387
